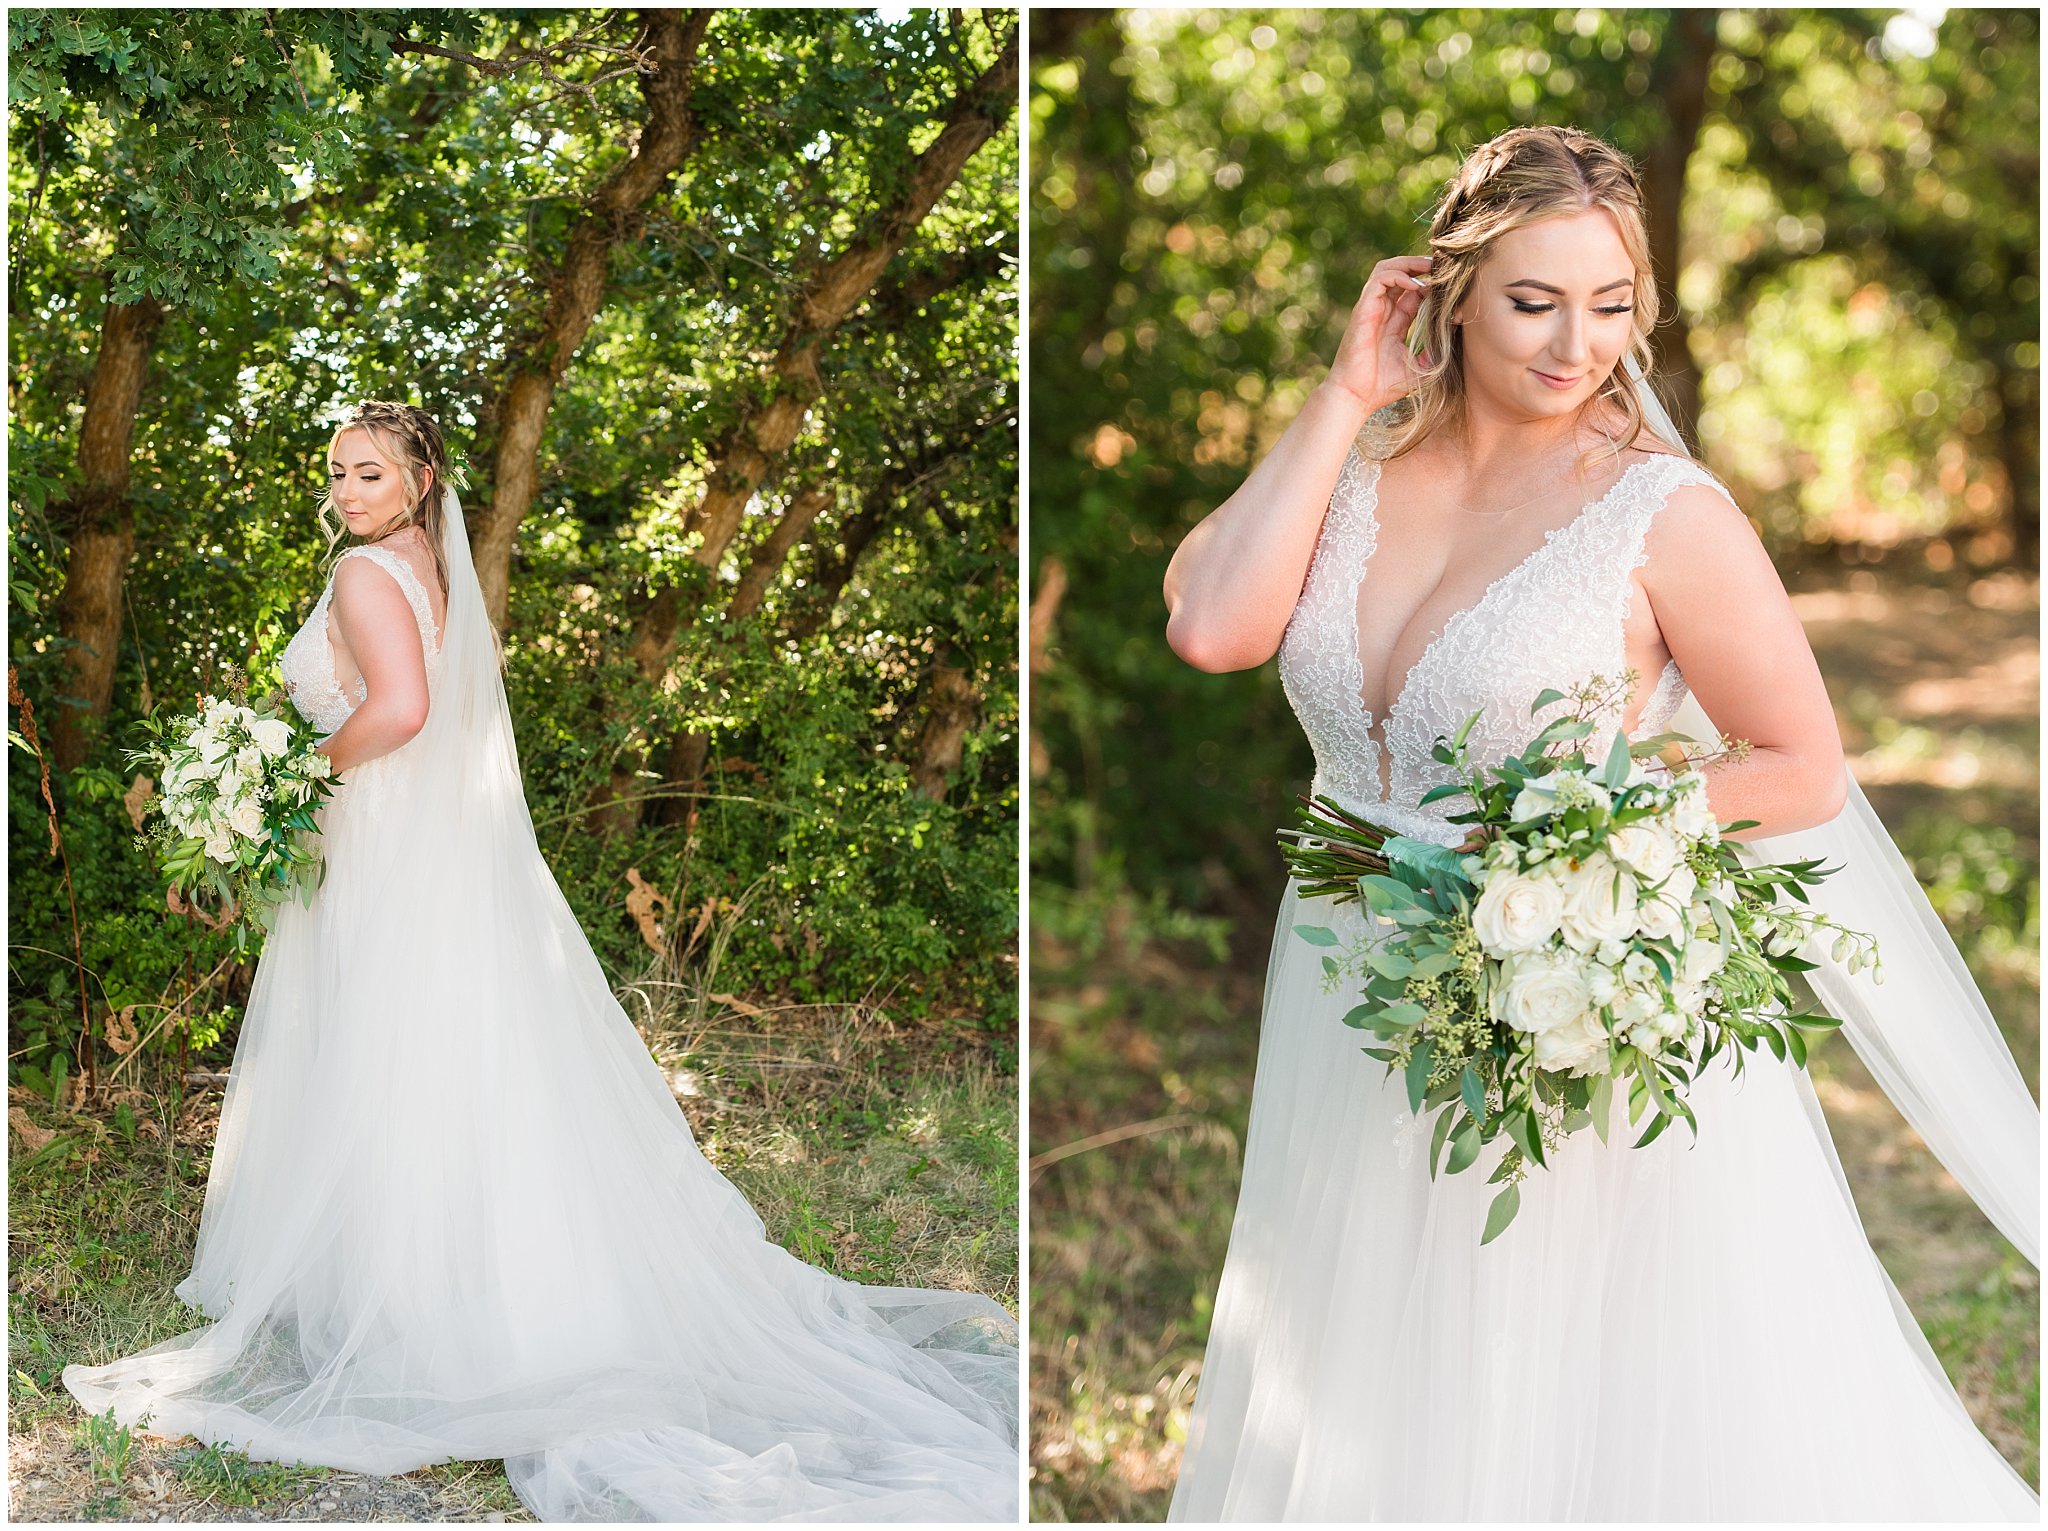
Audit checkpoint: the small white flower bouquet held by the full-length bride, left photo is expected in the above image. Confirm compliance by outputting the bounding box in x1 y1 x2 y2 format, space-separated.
127 671 334 952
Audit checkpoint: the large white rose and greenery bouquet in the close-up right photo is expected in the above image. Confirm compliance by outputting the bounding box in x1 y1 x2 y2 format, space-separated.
1282 675 1884 1242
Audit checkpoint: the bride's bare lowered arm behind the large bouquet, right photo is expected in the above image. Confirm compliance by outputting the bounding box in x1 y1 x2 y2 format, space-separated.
1640 485 1849 839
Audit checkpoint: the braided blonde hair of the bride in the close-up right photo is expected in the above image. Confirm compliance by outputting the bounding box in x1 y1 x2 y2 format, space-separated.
1389 127 1657 456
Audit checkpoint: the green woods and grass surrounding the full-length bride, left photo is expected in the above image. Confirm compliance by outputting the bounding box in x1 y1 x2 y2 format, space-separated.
8 6 1020 1519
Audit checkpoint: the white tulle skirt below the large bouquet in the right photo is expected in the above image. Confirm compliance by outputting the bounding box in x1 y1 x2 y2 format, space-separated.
1171 884 2040 1521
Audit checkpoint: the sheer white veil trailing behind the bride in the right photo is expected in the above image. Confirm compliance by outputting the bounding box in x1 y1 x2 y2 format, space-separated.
1628 358 2040 1269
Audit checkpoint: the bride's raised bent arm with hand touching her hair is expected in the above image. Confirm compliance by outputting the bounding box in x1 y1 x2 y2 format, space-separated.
1165 256 1430 671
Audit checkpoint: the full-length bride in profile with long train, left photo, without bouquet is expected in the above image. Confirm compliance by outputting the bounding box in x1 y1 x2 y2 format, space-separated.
63 401 1020 1521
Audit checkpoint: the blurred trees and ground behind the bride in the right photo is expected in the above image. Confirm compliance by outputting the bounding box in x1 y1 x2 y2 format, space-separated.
1028 8 2040 1521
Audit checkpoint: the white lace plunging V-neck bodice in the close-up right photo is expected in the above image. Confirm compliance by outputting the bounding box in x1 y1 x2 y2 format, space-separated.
1280 428 1726 843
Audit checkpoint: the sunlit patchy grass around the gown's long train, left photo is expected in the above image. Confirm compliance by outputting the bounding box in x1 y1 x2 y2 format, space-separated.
8 974 1018 1521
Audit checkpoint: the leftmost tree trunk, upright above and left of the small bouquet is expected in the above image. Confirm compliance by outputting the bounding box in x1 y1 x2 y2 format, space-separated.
51 297 164 770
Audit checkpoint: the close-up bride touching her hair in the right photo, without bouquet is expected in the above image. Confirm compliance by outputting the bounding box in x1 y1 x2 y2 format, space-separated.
1165 127 2040 1521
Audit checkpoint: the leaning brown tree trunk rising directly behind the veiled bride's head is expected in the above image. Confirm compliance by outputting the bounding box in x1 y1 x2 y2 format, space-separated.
469 10 713 628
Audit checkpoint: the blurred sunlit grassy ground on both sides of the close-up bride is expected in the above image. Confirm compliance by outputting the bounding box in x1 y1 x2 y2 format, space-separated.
1030 569 2040 1521
